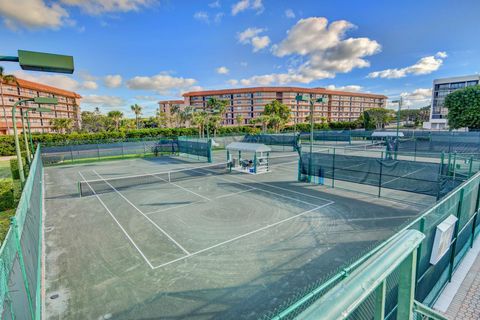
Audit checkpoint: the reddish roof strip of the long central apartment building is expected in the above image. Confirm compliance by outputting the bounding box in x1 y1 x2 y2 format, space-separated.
183 87 387 99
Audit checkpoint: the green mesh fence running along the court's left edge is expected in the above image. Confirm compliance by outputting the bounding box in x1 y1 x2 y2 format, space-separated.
0 145 43 319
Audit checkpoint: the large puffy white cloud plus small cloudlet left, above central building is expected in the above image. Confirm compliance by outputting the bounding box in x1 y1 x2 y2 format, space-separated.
231 17 381 85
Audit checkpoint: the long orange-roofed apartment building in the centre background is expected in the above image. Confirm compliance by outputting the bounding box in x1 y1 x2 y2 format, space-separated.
183 87 387 125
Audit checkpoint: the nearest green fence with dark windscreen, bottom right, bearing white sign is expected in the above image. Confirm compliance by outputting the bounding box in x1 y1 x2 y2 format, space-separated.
264 173 480 320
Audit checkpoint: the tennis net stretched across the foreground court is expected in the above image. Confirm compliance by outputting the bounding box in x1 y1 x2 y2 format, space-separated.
78 162 230 197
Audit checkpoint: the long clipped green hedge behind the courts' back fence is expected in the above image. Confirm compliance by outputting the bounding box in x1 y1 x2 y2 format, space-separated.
0 122 357 156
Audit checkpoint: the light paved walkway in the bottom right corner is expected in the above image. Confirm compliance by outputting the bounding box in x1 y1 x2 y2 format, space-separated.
434 237 480 320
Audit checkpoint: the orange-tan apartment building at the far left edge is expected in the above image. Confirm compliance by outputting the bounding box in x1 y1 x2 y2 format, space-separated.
0 78 81 134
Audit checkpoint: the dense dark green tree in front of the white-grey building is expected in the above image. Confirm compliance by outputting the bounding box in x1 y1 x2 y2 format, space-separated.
445 85 480 129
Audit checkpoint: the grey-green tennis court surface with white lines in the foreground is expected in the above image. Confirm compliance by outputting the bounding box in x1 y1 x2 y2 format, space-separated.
45 152 433 319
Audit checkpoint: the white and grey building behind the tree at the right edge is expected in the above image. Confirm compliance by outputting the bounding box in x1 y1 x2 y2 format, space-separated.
423 74 480 130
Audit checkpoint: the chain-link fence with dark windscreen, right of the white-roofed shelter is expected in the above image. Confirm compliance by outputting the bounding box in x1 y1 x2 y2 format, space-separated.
298 148 474 200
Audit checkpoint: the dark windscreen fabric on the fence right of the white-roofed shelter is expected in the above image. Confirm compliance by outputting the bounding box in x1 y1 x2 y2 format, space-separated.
299 152 463 197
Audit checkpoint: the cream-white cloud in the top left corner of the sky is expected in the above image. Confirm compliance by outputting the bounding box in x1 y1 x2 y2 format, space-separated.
0 0 69 29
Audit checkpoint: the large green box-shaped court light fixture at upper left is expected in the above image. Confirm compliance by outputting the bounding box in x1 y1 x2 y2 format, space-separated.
18 50 74 73
